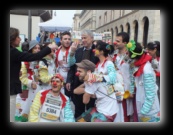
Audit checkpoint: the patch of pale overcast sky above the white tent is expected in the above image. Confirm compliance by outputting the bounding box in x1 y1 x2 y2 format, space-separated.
52 10 76 27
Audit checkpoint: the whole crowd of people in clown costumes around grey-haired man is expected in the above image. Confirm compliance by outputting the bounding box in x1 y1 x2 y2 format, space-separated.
10 28 160 122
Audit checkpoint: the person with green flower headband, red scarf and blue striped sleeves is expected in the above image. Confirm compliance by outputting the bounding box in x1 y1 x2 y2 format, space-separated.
126 40 160 122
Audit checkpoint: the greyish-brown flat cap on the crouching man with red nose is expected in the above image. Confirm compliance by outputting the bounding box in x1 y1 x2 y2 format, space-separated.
76 59 96 72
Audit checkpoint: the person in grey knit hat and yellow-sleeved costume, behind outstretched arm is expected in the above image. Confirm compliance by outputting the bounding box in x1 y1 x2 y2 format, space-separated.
20 40 41 122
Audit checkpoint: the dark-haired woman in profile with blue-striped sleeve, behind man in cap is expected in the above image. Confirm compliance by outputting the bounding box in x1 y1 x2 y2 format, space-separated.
90 40 124 106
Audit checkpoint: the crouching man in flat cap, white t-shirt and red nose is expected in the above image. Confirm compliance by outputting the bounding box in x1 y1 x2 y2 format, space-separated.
74 59 119 122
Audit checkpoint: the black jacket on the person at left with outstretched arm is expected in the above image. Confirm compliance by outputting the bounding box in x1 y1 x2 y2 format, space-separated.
10 46 51 95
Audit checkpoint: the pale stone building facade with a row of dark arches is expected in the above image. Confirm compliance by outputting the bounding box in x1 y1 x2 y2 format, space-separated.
73 10 160 46
